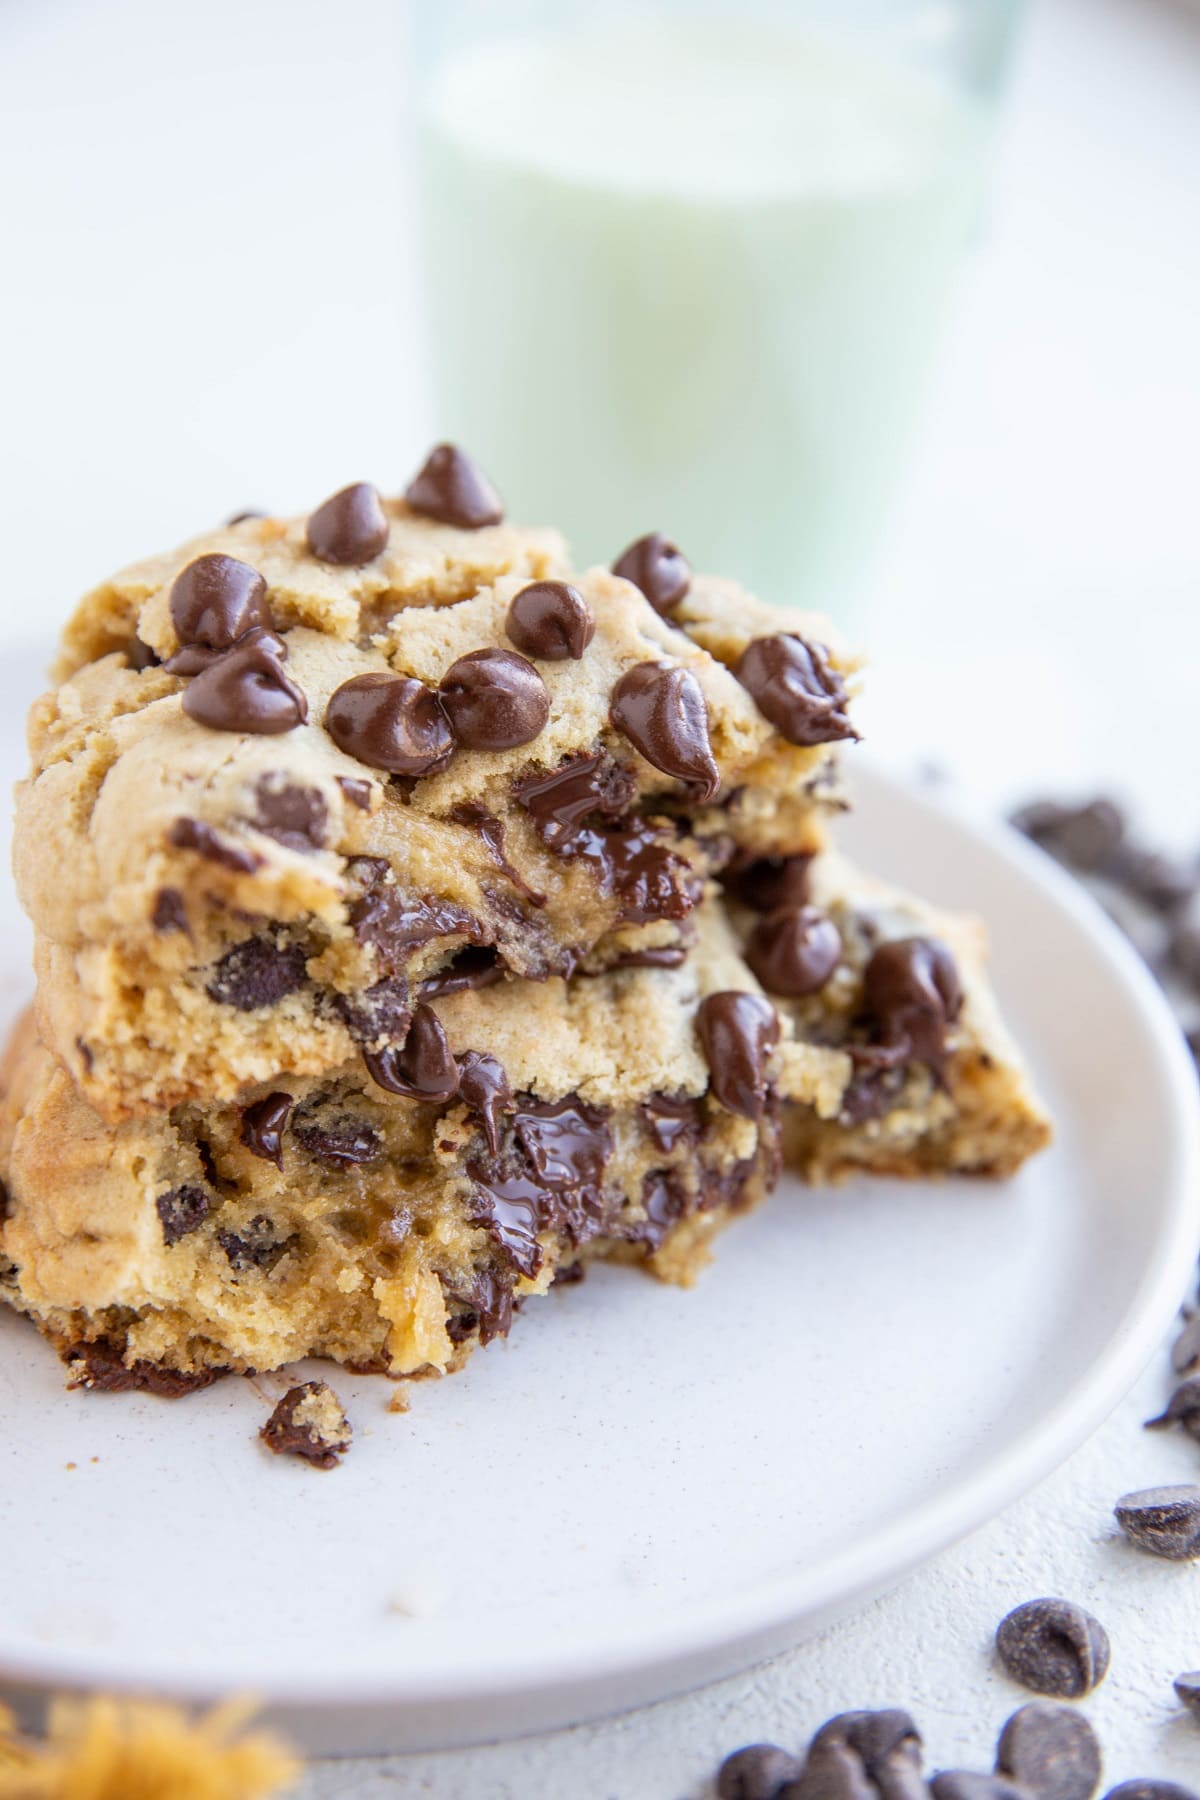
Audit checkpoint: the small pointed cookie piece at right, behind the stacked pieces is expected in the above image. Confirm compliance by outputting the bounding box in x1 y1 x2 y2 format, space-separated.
729 851 1051 1181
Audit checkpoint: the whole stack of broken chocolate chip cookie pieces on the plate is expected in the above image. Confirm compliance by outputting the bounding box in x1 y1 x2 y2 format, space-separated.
0 445 1047 1393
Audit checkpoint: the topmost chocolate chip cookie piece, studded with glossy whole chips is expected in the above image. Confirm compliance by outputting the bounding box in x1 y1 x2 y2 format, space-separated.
14 457 853 1121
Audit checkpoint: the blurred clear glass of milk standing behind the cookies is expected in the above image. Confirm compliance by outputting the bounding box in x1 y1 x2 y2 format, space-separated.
417 0 1018 614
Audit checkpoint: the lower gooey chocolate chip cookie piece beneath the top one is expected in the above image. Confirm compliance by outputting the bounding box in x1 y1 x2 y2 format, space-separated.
0 902 816 1393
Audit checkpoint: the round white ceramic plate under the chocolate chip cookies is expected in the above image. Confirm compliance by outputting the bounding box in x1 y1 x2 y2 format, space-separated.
0 651 1200 1751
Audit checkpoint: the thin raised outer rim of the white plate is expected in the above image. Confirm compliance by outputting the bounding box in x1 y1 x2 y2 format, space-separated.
0 760 1200 1713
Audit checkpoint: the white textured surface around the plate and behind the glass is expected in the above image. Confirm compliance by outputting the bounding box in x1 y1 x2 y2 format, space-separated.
0 0 1200 1800
